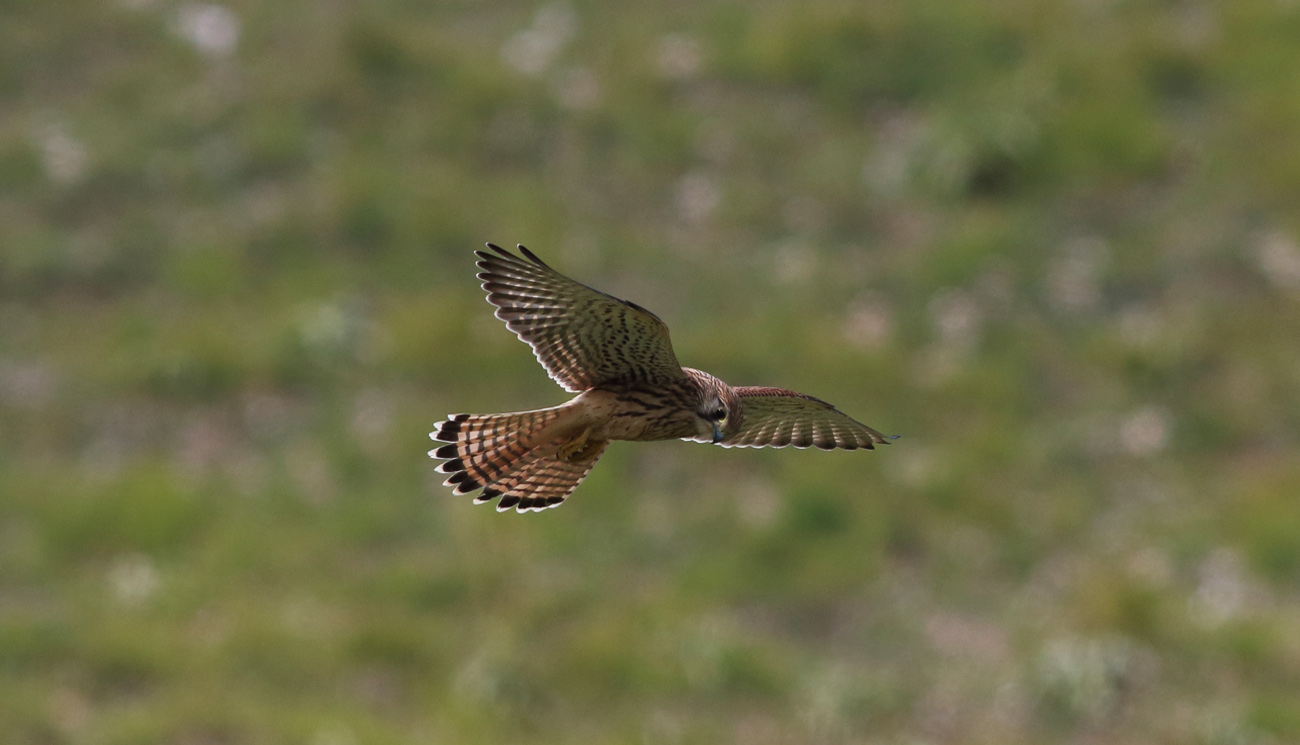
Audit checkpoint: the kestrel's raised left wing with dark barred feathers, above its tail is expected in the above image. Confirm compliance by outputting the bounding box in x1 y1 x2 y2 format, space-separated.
475 243 685 393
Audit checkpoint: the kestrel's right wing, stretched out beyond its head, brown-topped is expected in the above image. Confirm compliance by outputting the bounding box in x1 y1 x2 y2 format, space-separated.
720 386 892 450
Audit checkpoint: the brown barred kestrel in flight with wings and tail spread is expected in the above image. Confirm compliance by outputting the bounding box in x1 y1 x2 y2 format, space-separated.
429 243 889 512
